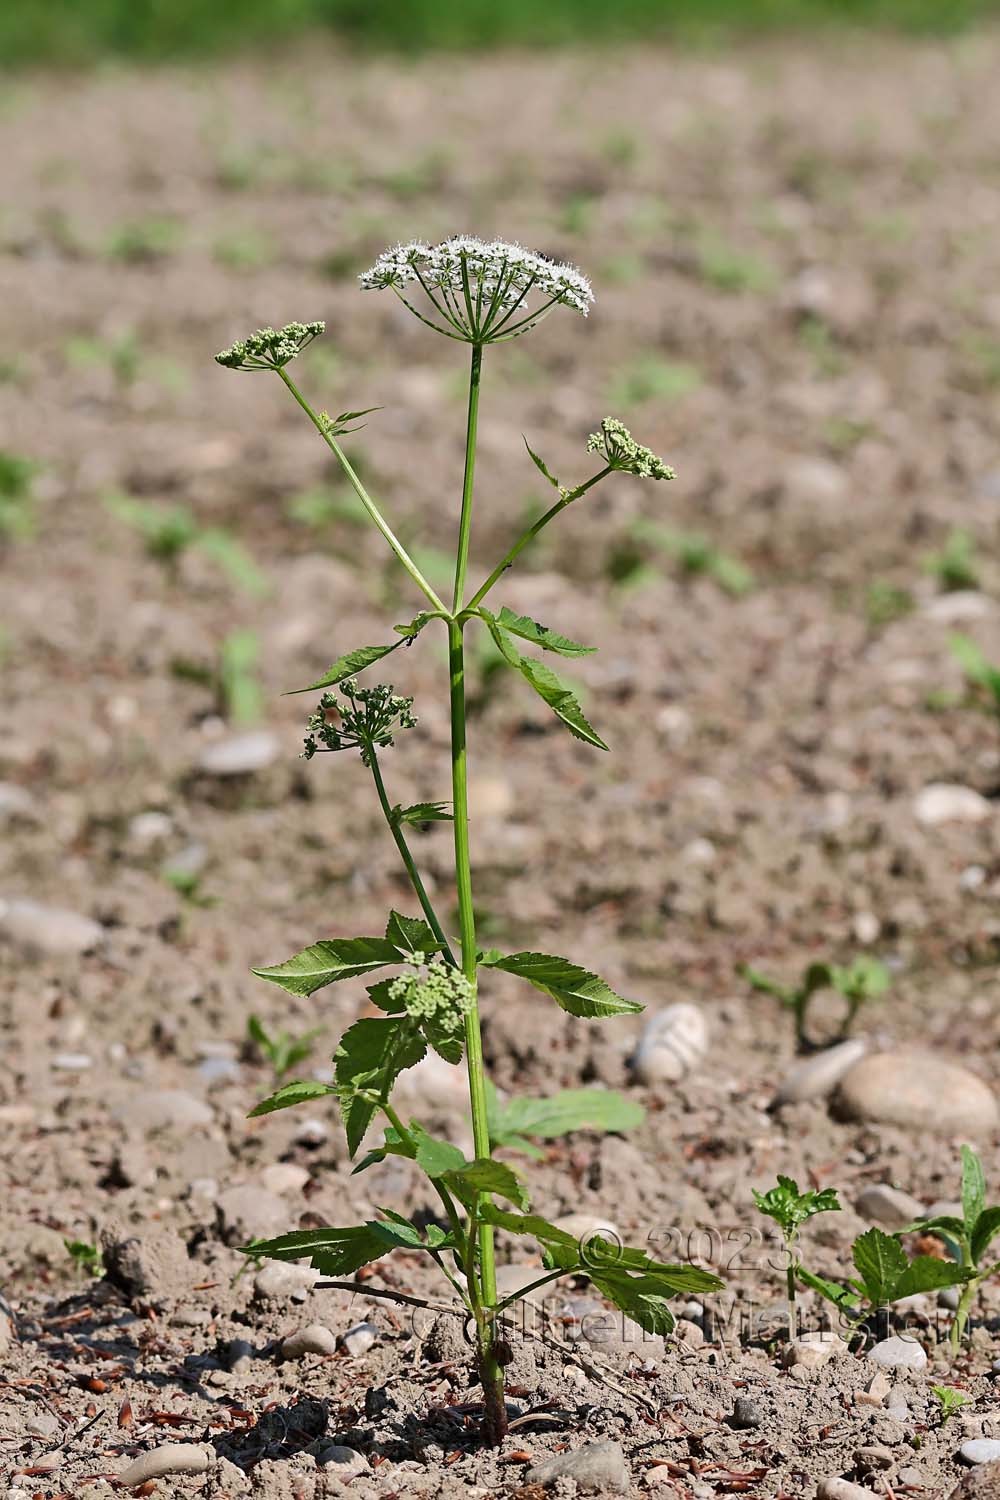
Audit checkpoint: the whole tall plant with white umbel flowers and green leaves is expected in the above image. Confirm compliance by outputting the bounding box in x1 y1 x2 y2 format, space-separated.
217 237 720 1443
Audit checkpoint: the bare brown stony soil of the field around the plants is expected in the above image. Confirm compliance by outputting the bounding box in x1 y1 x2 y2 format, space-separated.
0 36 1000 1500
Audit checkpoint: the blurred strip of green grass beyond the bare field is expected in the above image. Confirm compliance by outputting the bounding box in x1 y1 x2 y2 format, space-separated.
0 0 1000 68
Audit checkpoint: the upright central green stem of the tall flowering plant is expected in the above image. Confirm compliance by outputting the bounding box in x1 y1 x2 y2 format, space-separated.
448 344 507 1445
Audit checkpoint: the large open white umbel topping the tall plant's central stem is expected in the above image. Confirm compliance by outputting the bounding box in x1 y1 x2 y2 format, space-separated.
360 234 594 344
